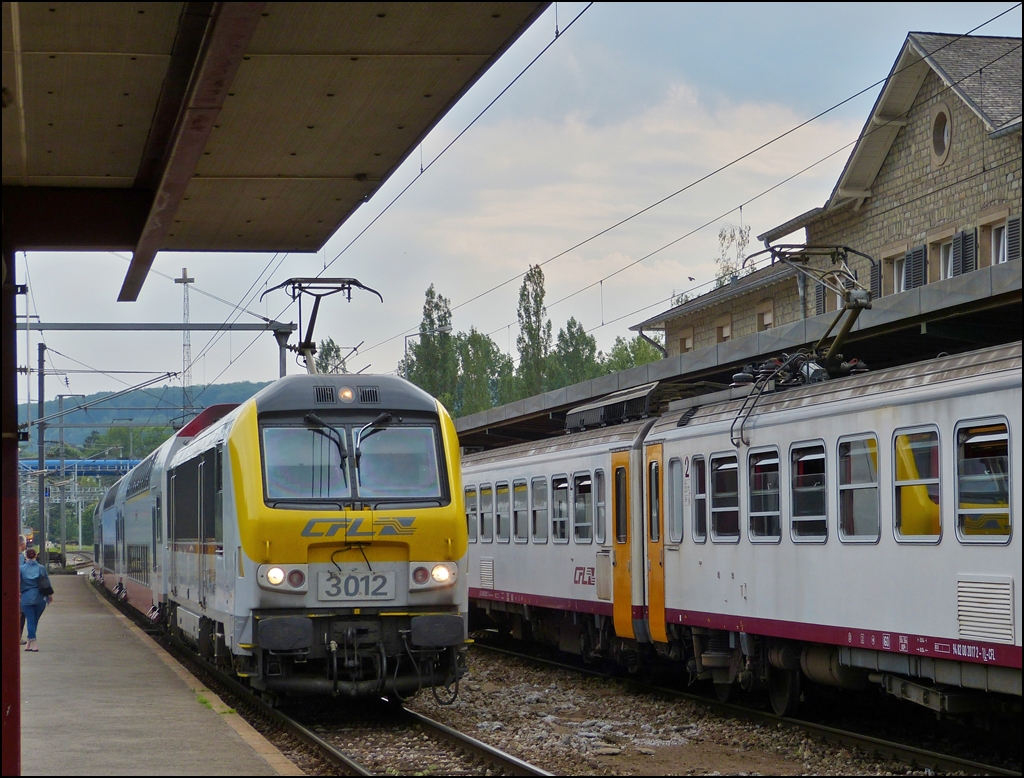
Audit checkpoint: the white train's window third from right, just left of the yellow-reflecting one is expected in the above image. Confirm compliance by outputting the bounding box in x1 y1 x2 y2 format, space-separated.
839 435 880 543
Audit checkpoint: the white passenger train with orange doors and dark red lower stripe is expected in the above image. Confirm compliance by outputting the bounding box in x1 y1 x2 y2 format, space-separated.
463 342 1024 714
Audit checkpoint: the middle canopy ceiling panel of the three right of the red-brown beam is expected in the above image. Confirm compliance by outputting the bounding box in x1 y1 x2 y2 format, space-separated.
197 56 485 181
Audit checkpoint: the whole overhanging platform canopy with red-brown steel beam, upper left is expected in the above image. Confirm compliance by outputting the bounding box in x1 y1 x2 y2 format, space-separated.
3 2 548 301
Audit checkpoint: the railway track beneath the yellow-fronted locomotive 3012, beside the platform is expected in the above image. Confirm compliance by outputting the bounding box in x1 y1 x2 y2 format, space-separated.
101 590 553 776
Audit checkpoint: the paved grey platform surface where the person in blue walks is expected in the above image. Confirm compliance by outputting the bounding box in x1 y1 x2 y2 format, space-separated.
22 575 302 775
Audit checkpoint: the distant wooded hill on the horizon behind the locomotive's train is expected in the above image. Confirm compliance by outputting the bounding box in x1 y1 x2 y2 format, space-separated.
17 381 270 446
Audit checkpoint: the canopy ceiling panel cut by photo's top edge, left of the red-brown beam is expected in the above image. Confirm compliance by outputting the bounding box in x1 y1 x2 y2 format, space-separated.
18 2 183 54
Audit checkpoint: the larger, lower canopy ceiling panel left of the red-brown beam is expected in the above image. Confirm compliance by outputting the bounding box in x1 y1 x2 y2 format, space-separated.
19 53 169 185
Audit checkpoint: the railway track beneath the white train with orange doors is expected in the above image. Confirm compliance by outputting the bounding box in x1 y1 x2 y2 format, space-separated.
473 641 1021 776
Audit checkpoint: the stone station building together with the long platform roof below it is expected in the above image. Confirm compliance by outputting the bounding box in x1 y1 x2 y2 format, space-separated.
457 32 1022 447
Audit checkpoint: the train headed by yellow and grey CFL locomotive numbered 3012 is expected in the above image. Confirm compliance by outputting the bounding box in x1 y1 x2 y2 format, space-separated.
95 375 468 698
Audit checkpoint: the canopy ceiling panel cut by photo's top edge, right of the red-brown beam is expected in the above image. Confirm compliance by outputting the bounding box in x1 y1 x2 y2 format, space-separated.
249 3 538 56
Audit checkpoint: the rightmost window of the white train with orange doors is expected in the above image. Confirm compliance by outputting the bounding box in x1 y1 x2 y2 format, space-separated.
956 420 1010 543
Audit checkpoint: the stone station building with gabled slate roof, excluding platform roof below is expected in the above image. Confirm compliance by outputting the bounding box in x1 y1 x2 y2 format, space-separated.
631 33 1021 356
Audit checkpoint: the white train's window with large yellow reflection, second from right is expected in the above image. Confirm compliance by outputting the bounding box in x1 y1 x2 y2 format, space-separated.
893 429 942 542
